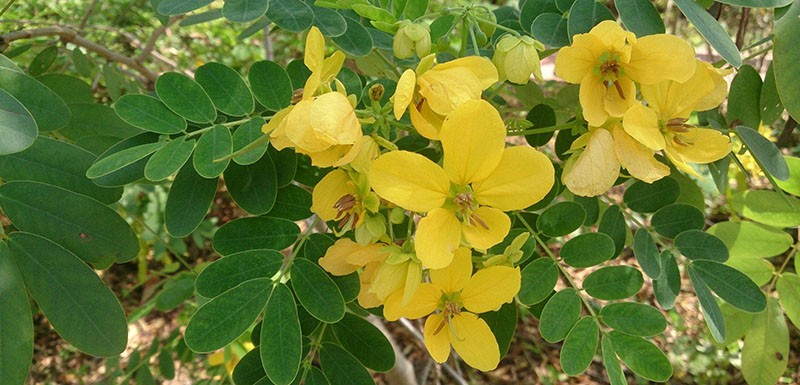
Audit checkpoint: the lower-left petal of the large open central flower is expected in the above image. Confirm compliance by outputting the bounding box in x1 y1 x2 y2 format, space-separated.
414 208 461 269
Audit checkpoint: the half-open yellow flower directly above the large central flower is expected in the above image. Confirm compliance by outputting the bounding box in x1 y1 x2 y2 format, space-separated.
392 55 497 140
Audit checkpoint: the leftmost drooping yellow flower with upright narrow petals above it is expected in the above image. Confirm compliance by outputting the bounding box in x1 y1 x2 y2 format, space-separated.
263 27 362 167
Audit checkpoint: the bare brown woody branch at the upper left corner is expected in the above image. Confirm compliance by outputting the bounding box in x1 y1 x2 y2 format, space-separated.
0 27 158 83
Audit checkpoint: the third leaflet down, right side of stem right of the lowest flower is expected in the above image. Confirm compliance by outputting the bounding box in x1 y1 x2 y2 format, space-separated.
583 266 644 301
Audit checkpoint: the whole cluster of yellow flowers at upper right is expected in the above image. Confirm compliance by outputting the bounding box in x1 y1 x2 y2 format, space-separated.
556 21 731 196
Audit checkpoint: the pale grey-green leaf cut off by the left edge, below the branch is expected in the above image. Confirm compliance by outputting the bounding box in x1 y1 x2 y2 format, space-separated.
0 89 39 155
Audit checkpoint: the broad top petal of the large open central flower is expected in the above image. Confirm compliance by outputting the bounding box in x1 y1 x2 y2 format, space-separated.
439 100 506 185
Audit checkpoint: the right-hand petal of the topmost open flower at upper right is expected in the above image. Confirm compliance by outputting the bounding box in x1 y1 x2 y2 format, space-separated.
622 34 695 84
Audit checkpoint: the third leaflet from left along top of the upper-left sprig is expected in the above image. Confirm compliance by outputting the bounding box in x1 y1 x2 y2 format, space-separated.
194 61 253 116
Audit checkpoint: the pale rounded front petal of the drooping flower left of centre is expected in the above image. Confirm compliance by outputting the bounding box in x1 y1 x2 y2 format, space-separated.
309 92 362 144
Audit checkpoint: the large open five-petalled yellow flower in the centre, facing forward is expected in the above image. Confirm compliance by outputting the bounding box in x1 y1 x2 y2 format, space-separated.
369 100 554 268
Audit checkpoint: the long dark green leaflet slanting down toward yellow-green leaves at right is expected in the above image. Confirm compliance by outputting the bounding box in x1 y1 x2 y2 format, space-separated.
689 260 767 313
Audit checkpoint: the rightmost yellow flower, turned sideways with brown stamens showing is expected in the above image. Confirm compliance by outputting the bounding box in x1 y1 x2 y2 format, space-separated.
622 61 731 175
